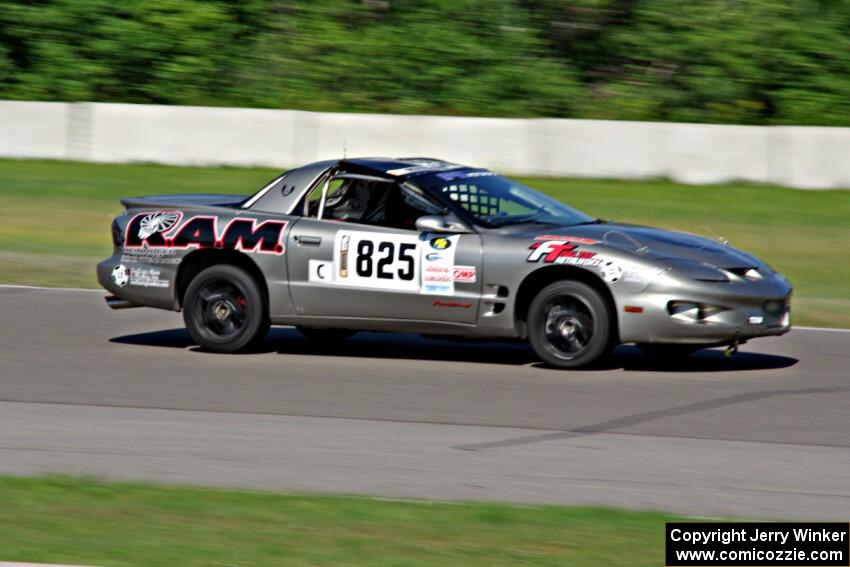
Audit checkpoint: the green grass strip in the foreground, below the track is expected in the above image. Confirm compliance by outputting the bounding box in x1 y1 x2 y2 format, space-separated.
0 477 675 567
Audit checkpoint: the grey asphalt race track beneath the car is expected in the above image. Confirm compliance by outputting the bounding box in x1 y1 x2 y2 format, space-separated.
0 287 850 521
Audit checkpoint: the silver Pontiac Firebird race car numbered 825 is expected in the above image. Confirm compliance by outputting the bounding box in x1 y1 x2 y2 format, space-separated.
97 158 791 368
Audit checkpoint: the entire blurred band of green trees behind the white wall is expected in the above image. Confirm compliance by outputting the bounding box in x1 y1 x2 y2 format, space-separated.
0 0 850 126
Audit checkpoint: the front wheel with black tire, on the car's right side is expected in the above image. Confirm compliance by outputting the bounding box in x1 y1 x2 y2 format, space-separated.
528 281 614 369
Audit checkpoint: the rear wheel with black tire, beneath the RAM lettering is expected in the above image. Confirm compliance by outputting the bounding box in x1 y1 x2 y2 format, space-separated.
183 264 269 352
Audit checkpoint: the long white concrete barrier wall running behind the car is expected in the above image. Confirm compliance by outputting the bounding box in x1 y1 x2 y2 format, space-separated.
0 101 850 189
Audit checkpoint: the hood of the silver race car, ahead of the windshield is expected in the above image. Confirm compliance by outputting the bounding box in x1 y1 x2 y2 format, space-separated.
509 223 765 269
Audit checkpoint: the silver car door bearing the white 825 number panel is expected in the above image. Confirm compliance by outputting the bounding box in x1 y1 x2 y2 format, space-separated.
287 180 482 324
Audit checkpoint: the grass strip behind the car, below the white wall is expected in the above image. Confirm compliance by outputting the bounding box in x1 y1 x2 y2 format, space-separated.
0 160 850 327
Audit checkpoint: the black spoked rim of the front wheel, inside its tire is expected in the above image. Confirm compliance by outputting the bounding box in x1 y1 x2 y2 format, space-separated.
543 295 594 360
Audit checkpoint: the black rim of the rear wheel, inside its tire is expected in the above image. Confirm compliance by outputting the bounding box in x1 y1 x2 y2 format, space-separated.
195 279 248 339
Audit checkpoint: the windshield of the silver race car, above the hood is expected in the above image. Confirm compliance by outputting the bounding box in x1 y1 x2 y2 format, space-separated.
410 169 595 228
